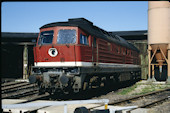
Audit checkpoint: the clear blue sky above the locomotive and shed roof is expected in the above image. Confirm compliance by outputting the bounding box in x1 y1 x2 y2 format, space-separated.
1 1 148 32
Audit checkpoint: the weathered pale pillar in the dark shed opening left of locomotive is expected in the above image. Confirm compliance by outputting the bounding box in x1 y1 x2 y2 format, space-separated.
23 45 28 79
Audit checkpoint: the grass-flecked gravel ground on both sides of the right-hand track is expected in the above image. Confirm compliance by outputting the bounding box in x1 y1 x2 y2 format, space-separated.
93 81 170 113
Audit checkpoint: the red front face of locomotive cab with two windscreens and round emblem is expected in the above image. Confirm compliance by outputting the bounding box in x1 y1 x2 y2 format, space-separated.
34 28 77 66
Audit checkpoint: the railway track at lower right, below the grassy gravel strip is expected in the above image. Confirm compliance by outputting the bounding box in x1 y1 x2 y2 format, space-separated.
90 88 170 109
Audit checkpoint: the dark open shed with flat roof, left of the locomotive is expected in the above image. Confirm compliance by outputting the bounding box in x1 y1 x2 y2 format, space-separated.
1 32 38 79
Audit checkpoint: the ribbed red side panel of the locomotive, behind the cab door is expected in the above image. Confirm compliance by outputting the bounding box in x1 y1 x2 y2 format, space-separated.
98 39 139 65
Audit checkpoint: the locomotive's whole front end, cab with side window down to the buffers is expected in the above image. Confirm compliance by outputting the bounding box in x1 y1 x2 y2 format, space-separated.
29 27 92 93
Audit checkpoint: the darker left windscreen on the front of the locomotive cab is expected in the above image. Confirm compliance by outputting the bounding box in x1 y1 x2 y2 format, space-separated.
38 31 54 45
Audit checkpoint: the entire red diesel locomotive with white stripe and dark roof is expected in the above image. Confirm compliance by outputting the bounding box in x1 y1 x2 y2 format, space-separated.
29 18 140 94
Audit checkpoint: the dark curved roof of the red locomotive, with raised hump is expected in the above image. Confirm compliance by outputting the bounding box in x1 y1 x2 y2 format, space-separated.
40 18 139 52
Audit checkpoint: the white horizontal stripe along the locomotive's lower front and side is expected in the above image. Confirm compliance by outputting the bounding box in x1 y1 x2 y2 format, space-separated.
34 62 140 68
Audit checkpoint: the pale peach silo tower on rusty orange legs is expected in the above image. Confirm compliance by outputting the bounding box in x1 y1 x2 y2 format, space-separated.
148 1 170 82
